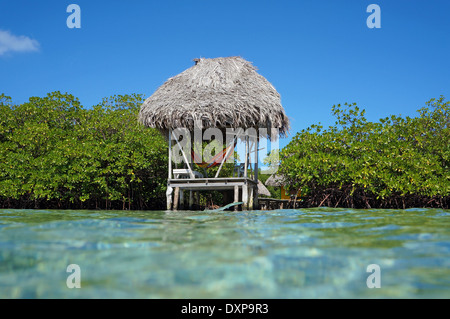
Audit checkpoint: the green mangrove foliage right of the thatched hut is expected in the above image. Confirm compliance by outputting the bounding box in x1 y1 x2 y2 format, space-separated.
279 96 450 208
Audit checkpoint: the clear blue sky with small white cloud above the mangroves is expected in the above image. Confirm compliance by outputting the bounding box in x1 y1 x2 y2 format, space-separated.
0 0 450 146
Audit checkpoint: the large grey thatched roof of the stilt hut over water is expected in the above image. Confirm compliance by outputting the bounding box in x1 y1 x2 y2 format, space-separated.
139 57 289 136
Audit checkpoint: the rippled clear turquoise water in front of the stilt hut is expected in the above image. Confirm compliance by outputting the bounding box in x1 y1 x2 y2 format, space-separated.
0 208 450 298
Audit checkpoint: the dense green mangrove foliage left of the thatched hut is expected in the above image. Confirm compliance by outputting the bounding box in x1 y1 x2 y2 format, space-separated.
0 92 167 209
